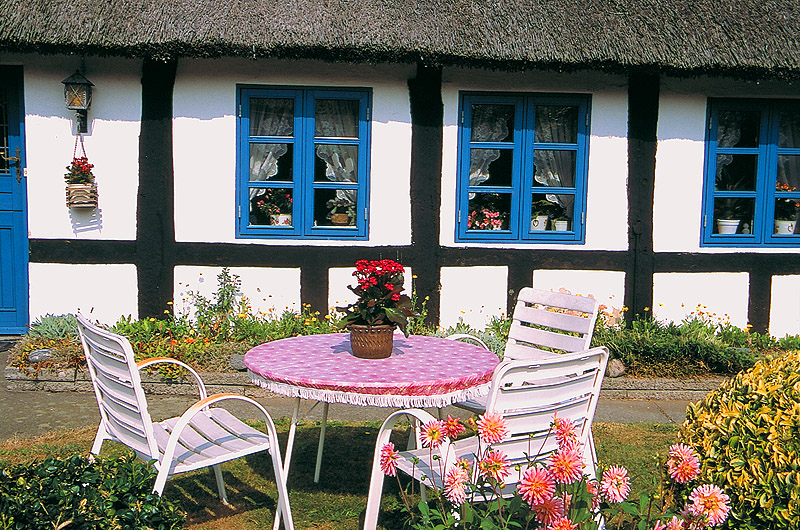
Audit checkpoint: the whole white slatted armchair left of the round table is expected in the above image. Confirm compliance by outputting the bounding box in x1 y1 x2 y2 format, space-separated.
78 315 294 530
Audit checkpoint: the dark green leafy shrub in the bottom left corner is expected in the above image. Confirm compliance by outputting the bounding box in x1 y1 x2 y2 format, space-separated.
0 455 185 530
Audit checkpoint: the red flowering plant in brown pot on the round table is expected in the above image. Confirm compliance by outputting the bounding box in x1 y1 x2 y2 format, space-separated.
336 259 416 358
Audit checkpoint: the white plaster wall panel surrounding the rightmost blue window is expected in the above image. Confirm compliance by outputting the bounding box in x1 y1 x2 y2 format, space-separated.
653 77 800 253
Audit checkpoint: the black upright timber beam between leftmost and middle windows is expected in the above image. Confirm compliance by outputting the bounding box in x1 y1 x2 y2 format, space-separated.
408 63 444 324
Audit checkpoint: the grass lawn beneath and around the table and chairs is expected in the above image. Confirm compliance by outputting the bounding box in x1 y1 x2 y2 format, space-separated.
0 418 677 530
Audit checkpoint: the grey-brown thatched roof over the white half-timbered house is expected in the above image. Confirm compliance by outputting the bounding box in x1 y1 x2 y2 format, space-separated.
0 0 800 77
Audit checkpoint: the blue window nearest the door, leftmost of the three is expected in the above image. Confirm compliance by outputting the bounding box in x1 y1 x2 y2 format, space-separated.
237 86 371 239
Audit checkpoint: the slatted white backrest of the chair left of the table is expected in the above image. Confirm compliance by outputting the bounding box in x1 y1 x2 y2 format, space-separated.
77 315 159 460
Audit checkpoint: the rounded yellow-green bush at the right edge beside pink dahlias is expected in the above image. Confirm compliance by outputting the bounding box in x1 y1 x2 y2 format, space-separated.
679 351 800 530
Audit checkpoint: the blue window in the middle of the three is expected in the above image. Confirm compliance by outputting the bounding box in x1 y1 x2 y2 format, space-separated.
456 93 590 243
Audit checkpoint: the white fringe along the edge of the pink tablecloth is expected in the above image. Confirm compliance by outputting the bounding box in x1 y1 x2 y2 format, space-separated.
254 378 491 408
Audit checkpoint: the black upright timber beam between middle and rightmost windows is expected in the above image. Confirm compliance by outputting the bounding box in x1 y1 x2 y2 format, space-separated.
625 73 659 319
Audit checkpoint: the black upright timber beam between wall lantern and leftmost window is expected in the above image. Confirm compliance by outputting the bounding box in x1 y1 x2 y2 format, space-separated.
135 59 177 318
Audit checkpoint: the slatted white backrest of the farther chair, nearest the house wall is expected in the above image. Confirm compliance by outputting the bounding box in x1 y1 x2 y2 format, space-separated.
503 287 599 360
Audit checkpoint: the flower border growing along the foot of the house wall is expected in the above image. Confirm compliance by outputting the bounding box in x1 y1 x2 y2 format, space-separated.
8 268 800 377
